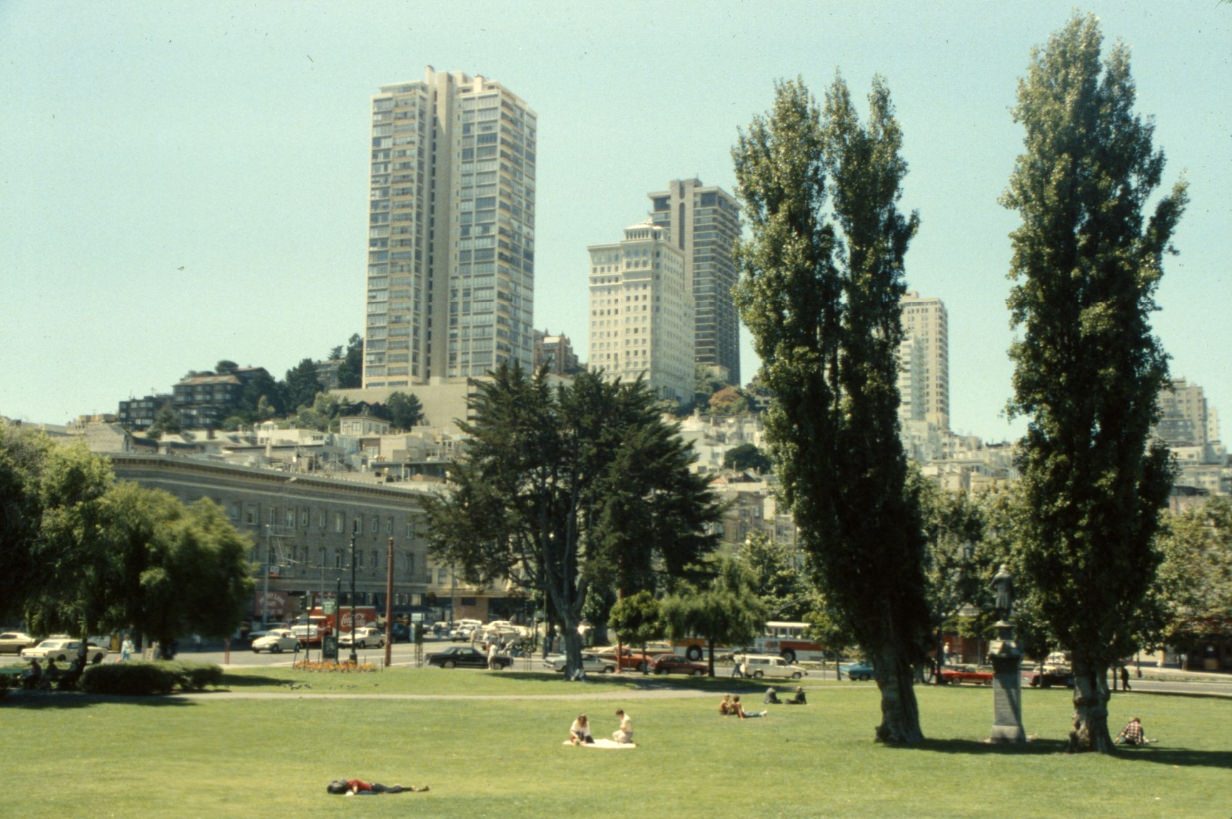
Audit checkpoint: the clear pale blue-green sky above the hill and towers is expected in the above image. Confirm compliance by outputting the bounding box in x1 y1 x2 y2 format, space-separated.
0 0 1232 440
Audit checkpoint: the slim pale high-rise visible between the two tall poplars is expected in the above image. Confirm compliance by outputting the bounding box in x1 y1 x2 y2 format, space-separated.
898 292 950 432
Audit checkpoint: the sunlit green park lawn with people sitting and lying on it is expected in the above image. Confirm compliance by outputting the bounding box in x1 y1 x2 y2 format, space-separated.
0 669 1232 817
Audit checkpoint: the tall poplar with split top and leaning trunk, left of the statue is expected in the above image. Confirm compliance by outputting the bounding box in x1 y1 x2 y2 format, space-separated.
733 78 928 743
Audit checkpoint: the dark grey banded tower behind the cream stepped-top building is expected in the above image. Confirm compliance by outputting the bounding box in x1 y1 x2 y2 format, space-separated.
649 179 740 385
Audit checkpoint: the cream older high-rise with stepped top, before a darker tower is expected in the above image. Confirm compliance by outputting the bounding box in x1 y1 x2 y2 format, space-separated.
588 224 694 403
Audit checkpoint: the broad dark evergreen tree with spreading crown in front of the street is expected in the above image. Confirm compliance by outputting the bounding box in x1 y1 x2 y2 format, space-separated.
426 365 718 672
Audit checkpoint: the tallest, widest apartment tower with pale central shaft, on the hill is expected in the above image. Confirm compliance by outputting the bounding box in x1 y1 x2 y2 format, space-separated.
363 67 536 388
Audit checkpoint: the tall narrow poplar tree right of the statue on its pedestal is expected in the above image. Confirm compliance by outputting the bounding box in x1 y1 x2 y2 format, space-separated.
1003 16 1185 751
